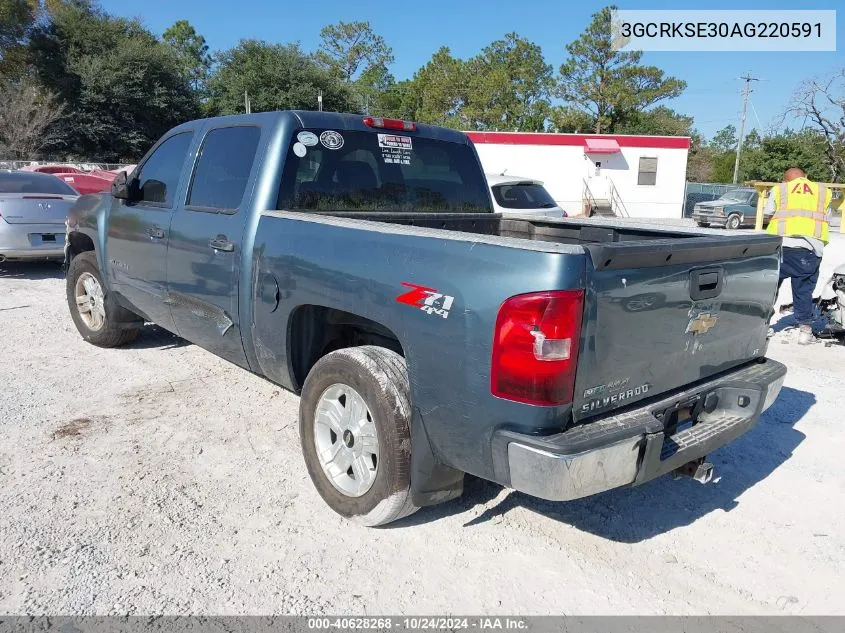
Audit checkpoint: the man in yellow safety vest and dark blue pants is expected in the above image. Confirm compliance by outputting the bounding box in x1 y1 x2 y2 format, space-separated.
766 167 833 345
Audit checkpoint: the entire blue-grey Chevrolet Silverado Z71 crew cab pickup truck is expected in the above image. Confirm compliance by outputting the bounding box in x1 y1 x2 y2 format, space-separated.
66 112 785 525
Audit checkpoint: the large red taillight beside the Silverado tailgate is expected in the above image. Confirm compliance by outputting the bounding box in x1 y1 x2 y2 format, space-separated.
490 290 584 406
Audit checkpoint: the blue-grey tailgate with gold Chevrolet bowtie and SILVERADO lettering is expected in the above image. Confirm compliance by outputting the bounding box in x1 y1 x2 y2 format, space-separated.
573 234 780 420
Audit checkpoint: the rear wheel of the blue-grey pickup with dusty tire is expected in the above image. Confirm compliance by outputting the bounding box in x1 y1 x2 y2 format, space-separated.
299 345 417 526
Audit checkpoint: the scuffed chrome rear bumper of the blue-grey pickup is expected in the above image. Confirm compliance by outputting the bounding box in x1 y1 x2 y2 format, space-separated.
502 359 786 501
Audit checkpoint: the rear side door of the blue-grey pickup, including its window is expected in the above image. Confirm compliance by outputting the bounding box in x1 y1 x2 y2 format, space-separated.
162 125 261 367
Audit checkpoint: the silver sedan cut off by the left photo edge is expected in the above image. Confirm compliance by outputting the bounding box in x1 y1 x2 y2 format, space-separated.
0 171 79 262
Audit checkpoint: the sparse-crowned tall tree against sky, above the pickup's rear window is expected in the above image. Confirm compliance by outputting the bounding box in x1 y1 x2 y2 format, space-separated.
316 22 393 82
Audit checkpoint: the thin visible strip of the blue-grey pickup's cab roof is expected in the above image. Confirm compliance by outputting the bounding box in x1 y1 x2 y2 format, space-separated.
165 110 468 143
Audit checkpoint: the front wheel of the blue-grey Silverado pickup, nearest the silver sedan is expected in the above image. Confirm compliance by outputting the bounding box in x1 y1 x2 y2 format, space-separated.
66 251 140 347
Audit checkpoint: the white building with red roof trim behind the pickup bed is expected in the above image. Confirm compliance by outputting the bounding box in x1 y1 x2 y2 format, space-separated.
467 132 690 218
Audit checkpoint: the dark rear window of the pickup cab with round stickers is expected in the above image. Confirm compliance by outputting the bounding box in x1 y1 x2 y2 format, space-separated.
278 129 493 213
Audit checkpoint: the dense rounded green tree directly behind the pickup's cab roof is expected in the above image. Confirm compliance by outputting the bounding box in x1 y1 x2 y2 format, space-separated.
208 40 354 114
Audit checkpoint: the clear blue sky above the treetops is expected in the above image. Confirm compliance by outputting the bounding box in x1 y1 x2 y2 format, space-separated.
101 0 845 138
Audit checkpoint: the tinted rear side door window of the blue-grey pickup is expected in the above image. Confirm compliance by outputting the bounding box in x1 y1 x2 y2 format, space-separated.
188 126 261 210
